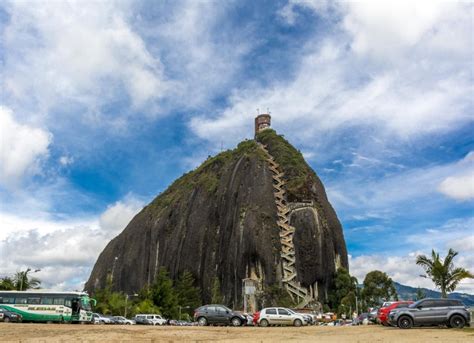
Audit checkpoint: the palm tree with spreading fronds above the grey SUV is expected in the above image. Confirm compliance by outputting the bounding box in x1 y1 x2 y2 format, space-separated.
416 249 474 298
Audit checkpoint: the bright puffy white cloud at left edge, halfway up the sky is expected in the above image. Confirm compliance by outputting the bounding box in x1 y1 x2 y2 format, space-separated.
0 106 52 188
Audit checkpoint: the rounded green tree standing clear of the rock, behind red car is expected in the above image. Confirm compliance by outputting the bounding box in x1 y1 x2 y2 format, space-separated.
362 270 398 307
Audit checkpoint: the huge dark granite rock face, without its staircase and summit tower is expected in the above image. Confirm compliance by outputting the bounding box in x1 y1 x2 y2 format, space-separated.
85 130 348 306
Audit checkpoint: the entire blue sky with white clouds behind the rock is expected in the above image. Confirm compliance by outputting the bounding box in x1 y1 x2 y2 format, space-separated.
0 0 474 293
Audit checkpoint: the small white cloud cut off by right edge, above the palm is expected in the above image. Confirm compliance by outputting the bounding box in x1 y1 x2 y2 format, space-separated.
438 152 474 200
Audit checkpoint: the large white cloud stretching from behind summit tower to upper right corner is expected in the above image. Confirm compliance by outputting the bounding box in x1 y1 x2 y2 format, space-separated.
190 2 473 148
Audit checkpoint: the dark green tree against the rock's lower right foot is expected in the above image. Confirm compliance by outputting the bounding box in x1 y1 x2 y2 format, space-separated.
328 268 358 315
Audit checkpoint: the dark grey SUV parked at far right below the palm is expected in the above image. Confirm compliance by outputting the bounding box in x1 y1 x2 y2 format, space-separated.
389 299 471 329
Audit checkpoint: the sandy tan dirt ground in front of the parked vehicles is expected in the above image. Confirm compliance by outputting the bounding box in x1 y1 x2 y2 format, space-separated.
0 323 474 343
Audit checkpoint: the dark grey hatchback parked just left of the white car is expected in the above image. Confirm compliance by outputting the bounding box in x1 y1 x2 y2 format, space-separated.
194 305 247 326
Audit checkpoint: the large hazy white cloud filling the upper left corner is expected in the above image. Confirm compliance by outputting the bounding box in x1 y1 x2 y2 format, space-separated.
2 1 168 124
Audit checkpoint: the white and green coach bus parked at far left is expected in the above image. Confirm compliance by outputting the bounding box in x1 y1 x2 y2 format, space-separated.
0 290 95 323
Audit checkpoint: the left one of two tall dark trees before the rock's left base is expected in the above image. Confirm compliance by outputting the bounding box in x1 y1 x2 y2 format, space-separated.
150 268 178 318
